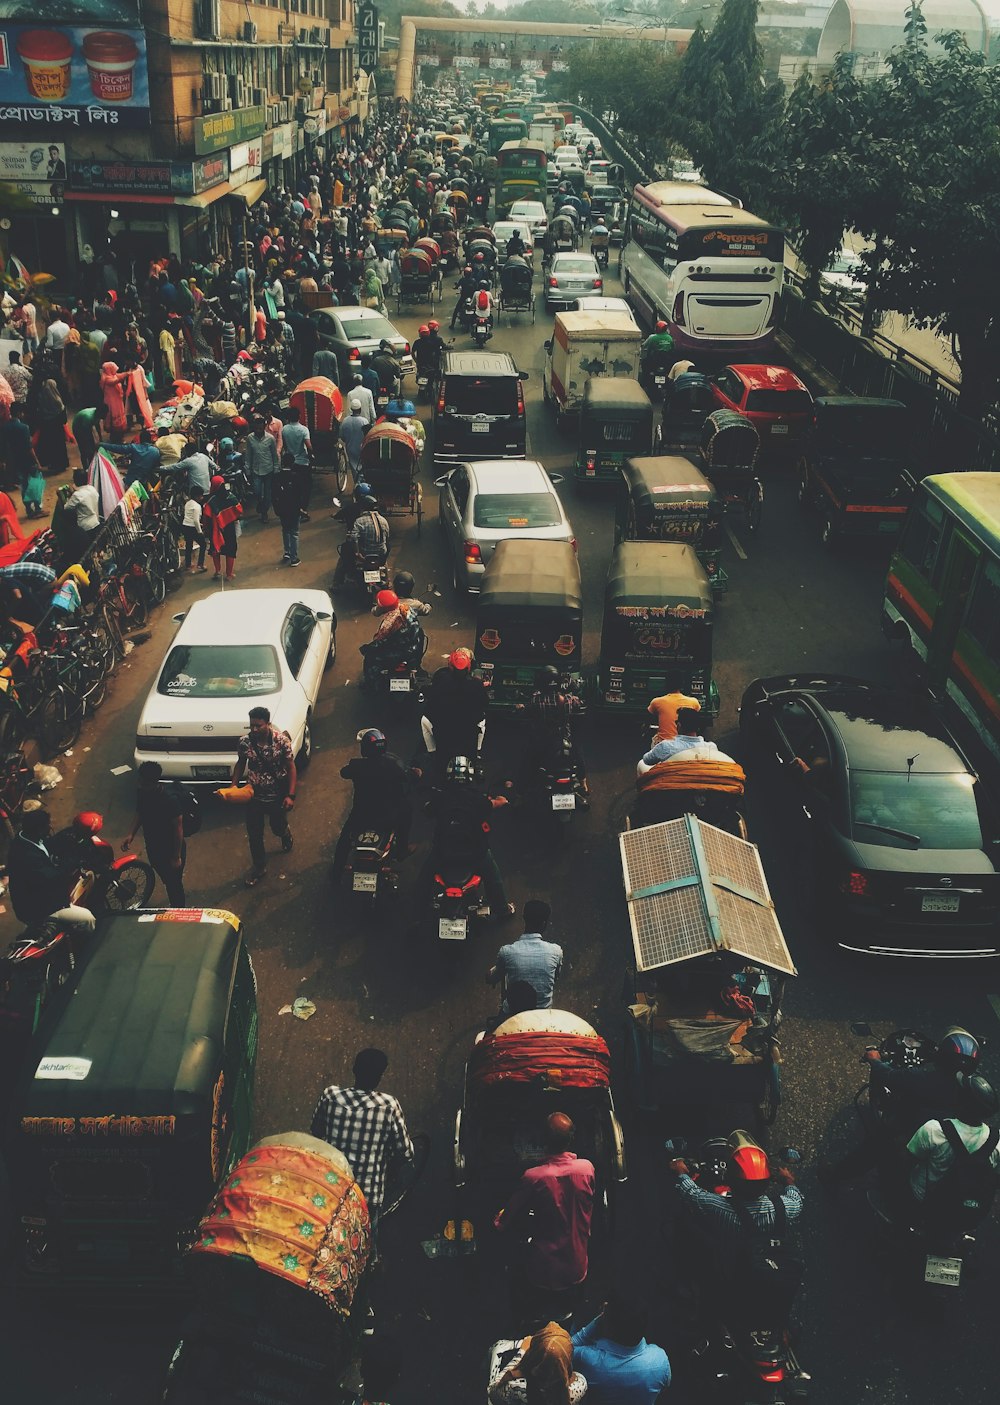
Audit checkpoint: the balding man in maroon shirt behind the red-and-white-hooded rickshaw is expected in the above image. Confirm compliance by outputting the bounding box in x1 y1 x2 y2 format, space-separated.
493 1113 596 1321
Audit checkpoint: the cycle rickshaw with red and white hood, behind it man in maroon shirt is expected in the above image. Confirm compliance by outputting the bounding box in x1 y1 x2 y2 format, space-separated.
454 1010 628 1215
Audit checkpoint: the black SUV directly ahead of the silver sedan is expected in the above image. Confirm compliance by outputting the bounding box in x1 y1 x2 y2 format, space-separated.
434 351 527 464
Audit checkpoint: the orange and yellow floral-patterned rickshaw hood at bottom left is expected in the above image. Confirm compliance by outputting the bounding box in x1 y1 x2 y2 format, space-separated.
191 1145 371 1316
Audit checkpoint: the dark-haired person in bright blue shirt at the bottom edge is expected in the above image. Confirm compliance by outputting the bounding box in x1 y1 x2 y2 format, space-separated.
572 1293 670 1405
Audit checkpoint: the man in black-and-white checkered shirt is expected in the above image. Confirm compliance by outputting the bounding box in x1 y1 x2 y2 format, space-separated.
312 1050 413 1242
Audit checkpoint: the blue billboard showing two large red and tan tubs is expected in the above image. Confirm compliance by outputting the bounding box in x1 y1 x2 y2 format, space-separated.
0 21 149 131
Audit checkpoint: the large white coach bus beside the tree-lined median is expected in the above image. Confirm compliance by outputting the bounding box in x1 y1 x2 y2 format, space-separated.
618 181 785 361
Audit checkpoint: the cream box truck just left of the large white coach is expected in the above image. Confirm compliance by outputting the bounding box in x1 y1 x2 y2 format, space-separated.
542 312 642 420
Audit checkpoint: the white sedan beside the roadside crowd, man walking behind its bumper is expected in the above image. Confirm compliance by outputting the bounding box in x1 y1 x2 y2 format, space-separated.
135 590 337 785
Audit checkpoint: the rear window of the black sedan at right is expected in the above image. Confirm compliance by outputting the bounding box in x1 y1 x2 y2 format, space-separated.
851 771 983 849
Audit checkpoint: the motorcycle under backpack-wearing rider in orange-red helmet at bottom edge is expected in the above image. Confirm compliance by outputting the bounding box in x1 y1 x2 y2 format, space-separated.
666 1130 812 1405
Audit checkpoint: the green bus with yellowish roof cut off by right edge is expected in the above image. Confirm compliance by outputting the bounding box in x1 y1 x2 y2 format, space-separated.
882 473 1000 762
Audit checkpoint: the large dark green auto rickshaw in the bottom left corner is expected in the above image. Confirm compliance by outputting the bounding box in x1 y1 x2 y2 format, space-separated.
6 908 257 1290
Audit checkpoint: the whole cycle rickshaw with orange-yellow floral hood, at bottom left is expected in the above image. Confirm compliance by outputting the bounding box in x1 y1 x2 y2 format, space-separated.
162 1132 371 1405
